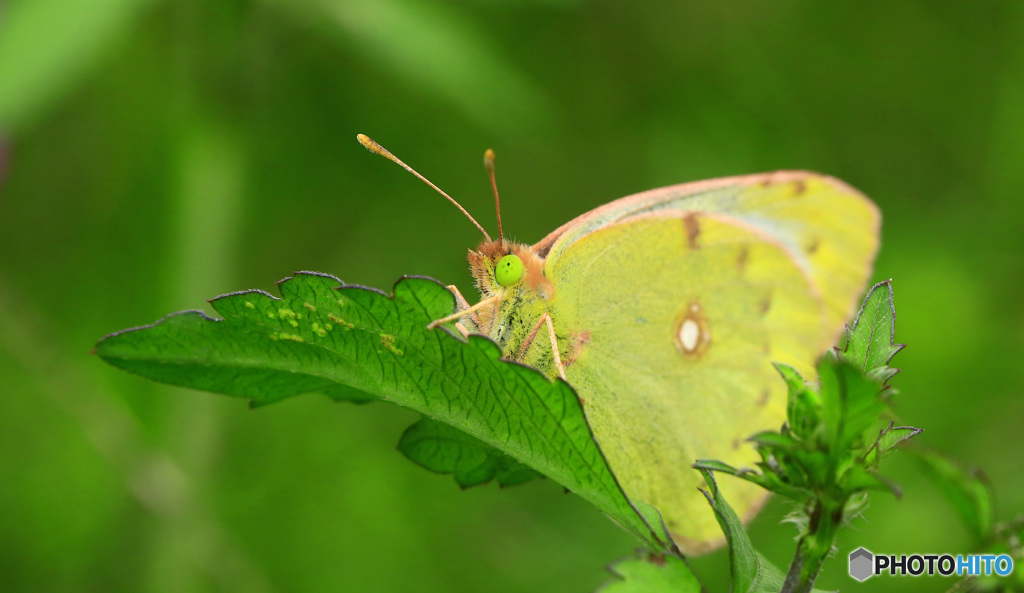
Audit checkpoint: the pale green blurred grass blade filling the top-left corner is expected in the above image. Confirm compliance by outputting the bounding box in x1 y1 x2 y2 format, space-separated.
0 0 154 133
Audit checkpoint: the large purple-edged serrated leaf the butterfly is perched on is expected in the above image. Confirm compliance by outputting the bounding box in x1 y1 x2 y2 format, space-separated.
95 272 666 550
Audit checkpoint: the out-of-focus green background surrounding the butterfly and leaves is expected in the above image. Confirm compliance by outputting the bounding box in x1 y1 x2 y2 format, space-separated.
0 0 1024 592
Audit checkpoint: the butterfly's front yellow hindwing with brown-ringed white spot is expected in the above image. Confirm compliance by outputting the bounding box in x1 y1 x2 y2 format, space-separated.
545 210 829 552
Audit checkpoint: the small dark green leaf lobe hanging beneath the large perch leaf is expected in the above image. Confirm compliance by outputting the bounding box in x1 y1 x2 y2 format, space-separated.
398 418 541 488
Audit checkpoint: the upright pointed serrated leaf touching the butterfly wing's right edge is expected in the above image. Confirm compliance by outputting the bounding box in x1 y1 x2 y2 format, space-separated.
843 281 904 384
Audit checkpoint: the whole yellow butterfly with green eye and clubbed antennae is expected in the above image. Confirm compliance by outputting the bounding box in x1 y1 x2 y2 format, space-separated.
358 134 881 554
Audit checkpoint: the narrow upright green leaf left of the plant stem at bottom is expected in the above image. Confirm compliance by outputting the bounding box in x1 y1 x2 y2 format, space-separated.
699 469 784 593
